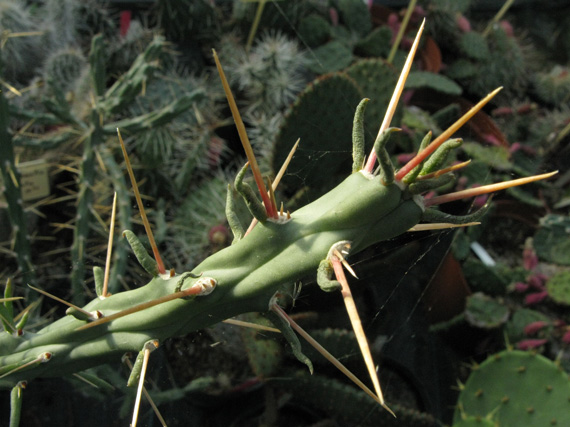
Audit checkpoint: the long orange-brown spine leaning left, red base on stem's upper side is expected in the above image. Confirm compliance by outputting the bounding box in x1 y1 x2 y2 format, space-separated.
212 49 277 219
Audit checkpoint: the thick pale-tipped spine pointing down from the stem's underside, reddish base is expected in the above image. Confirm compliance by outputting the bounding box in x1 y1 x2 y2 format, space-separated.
330 249 395 417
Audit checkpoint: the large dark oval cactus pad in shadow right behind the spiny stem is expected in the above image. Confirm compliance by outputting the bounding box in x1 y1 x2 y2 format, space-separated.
272 74 361 199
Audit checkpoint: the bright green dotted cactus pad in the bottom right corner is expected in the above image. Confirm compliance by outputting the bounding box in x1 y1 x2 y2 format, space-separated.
454 350 570 427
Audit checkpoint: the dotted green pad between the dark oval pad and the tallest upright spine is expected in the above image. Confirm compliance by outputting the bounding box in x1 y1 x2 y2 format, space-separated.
346 59 401 140
